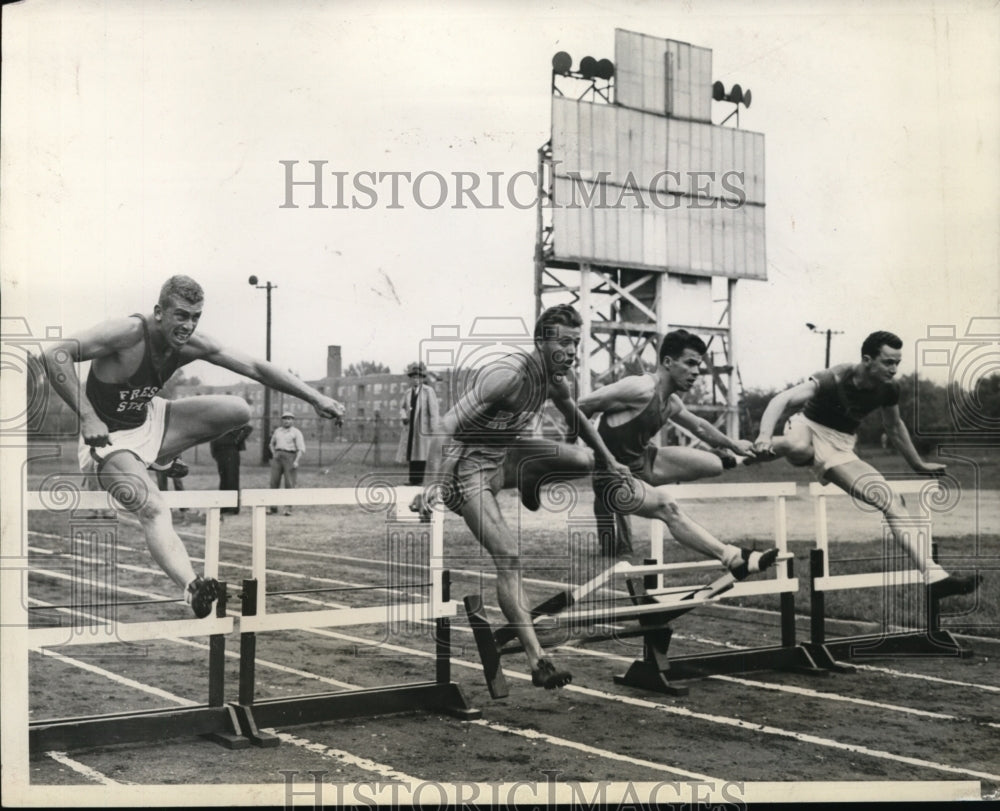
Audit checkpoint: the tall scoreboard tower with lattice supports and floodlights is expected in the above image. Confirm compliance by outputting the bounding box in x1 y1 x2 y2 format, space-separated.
535 29 767 436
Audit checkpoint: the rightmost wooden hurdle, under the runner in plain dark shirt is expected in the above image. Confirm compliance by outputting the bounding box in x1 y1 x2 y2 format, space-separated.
807 479 972 672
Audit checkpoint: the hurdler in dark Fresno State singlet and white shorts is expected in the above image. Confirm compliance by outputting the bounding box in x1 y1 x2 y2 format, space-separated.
44 276 344 618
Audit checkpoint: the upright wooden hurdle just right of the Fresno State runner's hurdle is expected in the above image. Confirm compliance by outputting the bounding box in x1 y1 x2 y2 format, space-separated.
234 486 481 747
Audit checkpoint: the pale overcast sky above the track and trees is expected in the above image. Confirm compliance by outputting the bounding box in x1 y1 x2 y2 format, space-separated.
0 0 1000 394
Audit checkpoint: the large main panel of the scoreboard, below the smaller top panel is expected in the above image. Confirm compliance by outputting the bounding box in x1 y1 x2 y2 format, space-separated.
552 93 767 279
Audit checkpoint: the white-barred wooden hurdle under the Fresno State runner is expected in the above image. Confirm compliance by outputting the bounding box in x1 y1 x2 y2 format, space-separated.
25 486 250 754
